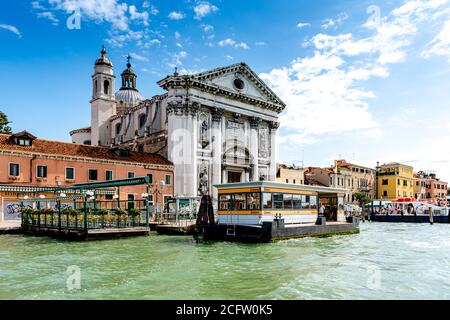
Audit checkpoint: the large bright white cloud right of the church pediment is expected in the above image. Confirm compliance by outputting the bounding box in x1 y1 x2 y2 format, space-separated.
261 0 446 143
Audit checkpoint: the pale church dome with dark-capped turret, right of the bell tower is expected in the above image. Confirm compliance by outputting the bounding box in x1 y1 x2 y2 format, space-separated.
116 56 145 108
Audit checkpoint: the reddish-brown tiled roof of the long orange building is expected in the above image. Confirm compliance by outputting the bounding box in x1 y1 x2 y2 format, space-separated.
0 134 173 166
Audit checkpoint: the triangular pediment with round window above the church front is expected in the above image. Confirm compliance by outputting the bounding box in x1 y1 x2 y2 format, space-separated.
192 63 285 108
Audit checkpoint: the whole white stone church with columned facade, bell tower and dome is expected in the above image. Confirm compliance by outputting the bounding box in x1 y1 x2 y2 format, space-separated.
70 48 285 198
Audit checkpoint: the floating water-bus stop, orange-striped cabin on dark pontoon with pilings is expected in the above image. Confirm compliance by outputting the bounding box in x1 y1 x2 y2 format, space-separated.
196 182 359 243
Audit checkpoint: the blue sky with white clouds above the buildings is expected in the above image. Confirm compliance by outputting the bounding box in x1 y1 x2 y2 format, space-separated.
0 0 450 181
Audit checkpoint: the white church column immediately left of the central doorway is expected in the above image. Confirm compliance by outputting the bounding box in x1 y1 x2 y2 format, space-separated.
210 108 224 201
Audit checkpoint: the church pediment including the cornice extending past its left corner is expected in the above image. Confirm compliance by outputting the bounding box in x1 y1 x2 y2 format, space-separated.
158 63 286 112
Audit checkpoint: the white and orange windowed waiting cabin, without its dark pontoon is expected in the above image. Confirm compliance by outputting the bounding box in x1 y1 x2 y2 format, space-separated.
215 182 345 225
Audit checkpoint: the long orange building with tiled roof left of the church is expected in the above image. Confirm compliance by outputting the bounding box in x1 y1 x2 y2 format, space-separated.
0 131 174 221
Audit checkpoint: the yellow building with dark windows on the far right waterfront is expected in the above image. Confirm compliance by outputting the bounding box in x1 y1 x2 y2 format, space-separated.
377 162 414 200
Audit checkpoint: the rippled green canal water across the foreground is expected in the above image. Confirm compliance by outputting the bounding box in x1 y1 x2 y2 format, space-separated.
0 223 450 299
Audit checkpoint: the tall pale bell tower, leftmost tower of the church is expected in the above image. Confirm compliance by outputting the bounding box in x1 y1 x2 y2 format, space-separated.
91 46 116 146
